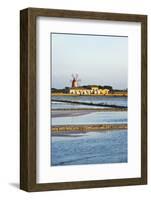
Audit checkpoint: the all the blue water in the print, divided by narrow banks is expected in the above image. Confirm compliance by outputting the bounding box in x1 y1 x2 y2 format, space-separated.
51 96 127 166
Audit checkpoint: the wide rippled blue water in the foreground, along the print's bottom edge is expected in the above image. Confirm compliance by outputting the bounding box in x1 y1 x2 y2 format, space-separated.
51 130 127 166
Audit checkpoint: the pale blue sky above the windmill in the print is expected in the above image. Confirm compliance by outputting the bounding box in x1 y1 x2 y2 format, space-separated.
51 33 128 89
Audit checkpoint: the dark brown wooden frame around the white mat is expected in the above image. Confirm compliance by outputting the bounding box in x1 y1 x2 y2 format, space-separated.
20 8 147 192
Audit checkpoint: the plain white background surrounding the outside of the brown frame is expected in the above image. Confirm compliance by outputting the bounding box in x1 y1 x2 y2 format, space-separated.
0 0 151 200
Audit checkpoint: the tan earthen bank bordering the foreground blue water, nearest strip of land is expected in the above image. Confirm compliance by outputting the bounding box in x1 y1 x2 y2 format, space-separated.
51 124 127 135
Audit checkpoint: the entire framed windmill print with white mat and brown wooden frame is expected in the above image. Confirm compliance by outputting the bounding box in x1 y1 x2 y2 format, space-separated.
20 8 147 192
